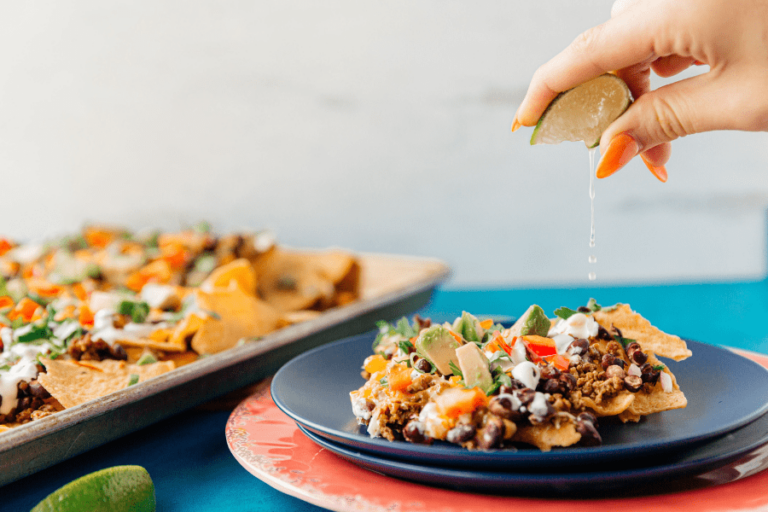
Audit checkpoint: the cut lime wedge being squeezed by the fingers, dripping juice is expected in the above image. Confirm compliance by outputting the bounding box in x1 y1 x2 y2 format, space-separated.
531 74 632 148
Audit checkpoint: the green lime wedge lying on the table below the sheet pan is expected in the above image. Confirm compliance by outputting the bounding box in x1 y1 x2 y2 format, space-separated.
32 466 155 512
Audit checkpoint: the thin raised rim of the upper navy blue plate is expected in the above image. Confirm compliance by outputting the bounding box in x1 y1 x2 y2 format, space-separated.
270 330 768 468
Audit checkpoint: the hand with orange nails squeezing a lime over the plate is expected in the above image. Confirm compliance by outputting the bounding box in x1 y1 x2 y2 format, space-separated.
512 0 768 181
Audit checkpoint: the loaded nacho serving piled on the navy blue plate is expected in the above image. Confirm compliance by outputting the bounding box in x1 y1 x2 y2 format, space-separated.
350 299 691 451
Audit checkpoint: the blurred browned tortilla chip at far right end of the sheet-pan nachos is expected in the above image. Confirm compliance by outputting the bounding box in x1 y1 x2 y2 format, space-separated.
253 248 360 311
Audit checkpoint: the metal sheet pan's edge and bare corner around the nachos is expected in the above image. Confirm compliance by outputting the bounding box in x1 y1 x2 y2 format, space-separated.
0 254 450 486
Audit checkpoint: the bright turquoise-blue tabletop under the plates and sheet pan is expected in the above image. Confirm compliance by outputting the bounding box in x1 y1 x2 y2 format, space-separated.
6 280 768 512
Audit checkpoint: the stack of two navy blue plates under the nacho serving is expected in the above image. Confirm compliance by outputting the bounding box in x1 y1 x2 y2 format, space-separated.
272 333 768 495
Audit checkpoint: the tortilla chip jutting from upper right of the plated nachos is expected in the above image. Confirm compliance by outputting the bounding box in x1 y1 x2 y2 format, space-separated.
594 304 691 361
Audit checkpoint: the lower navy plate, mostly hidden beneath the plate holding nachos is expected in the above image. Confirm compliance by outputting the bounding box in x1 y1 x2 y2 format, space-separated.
299 415 768 498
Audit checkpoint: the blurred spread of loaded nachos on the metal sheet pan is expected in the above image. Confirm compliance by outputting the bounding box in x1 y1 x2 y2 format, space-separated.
0 224 360 432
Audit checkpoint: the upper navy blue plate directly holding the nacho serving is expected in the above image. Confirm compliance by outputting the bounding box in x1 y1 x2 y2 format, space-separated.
272 333 768 472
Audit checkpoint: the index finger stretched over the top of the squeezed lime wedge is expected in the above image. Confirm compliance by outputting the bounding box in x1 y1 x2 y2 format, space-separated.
516 9 658 126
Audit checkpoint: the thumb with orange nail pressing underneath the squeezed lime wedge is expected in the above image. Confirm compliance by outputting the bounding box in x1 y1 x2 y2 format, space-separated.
596 73 749 181
